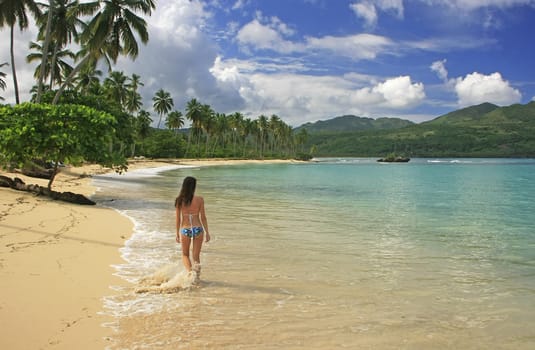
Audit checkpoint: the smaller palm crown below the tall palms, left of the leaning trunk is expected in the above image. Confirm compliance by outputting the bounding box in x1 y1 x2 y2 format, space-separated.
26 41 75 89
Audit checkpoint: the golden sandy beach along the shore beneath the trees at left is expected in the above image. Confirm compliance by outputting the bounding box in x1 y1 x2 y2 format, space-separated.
0 160 290 350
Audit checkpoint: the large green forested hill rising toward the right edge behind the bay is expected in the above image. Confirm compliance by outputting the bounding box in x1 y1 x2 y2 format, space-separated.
307 102 535 157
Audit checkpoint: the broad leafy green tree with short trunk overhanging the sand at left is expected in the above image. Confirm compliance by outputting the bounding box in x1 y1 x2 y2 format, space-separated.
0 103 126 189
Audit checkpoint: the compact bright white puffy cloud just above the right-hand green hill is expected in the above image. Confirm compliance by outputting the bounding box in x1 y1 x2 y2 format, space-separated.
455 72 522 107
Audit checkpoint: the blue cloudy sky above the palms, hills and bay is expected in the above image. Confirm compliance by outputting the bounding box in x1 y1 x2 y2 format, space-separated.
0 0 535 127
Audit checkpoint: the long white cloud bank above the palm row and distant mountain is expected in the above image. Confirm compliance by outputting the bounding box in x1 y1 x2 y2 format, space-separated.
212 54 425 126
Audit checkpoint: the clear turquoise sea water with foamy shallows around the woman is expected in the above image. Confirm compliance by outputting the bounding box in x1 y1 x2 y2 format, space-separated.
94 158 535 349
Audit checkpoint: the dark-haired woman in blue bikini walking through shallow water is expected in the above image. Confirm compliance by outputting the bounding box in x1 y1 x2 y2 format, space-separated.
175 176 210 279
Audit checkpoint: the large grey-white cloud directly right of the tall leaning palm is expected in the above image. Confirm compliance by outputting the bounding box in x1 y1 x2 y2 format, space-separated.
115 0 243 119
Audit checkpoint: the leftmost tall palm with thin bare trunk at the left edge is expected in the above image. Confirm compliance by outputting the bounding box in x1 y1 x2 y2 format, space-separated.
0 0 40 104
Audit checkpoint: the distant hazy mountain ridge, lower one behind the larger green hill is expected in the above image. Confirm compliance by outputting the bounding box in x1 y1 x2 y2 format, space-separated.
296 115 414 133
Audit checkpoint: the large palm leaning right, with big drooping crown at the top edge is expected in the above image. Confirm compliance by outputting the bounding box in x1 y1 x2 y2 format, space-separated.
52 0 156 103
